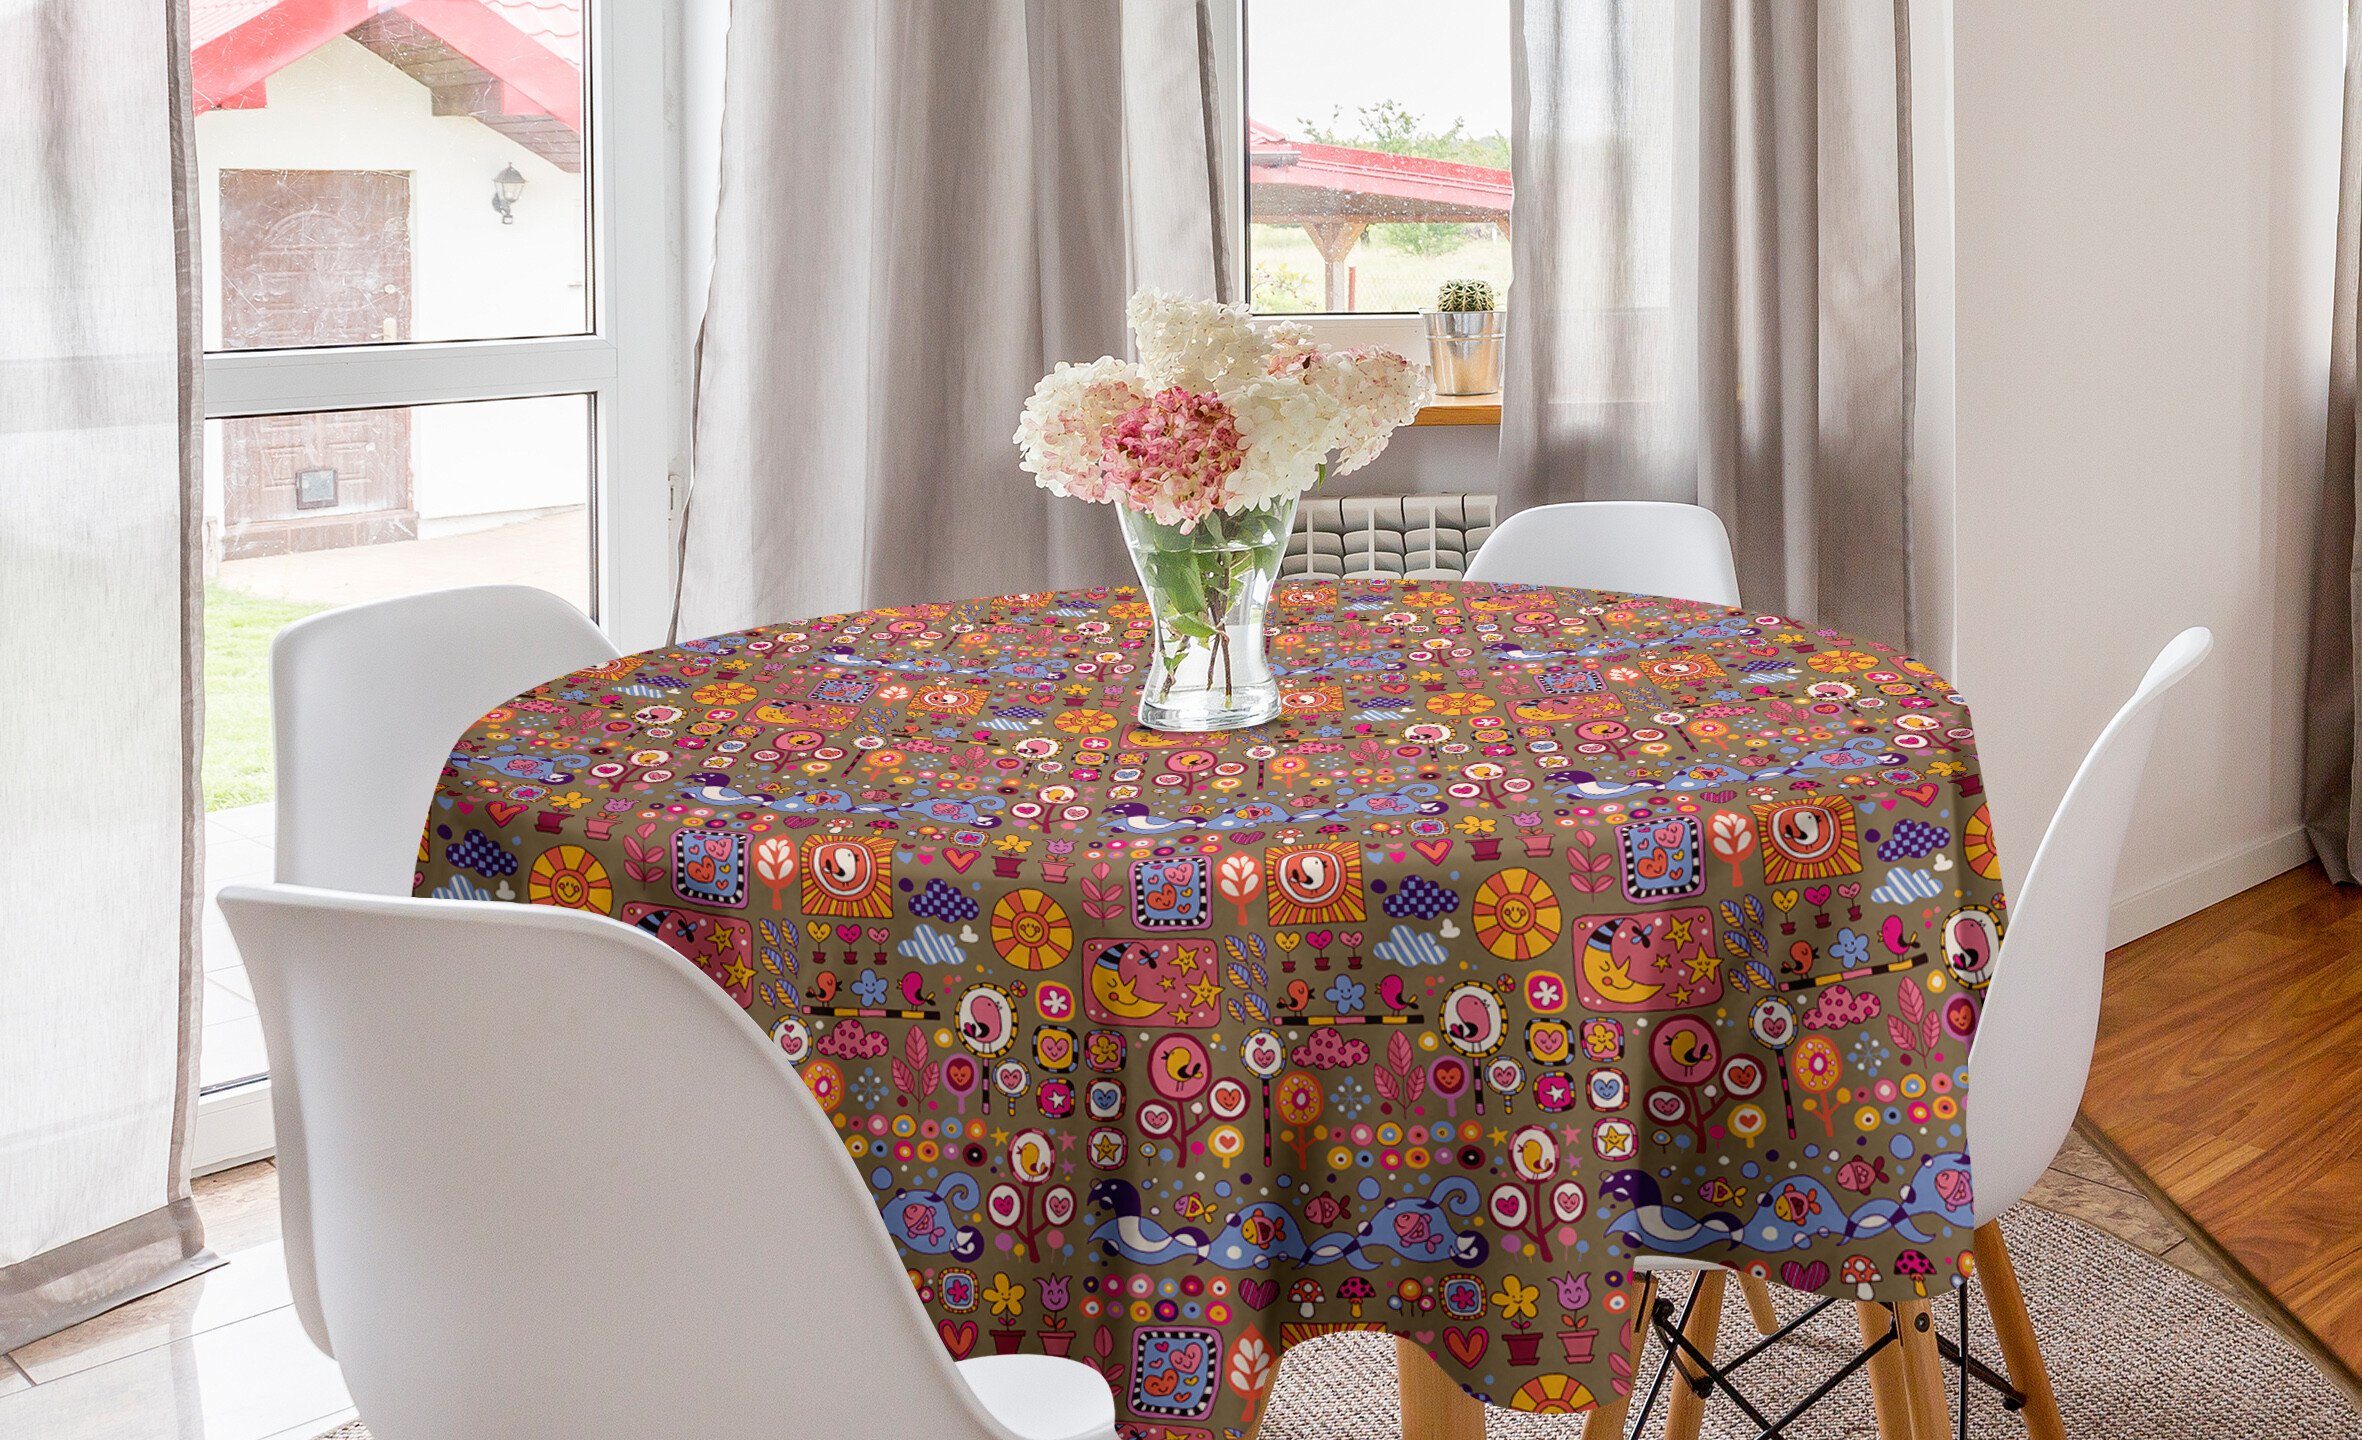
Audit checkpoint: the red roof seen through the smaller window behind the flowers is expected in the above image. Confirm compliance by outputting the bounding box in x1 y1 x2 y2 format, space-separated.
1247 120 1509 220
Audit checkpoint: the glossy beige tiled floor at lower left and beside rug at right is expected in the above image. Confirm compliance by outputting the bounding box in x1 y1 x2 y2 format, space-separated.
0 1123 2305 1440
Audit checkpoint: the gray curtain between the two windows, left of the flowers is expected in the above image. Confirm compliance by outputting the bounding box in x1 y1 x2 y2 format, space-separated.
676 0 1226 635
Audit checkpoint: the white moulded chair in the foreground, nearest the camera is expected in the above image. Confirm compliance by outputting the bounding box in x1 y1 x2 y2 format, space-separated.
222 885 1115 1440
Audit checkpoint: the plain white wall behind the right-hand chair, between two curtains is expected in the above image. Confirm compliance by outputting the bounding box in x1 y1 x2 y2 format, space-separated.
1953 0 2343 940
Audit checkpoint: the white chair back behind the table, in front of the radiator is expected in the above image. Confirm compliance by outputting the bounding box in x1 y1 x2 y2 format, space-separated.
1467 500 1738 609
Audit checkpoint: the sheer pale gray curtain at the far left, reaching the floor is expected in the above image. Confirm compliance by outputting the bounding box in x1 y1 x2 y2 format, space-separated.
0 0 215 1350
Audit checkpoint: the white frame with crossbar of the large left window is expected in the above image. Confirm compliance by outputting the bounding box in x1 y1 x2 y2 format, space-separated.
189 0 690 1176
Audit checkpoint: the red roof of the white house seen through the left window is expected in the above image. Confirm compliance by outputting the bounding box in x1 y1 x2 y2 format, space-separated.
189 0 583 135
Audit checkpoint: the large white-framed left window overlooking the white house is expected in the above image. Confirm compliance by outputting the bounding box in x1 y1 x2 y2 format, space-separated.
191 0 680 1088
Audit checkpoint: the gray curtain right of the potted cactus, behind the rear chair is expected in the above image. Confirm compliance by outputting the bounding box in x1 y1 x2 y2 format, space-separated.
1500 0 1916 642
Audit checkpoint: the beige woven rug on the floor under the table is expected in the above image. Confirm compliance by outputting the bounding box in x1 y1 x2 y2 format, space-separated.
319 1206 2362 1440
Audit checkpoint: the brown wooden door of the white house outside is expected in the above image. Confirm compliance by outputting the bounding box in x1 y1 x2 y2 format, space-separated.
222 170 418 559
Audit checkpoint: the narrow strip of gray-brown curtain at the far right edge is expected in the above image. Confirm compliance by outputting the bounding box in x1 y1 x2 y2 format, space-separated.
2305 7 2362 885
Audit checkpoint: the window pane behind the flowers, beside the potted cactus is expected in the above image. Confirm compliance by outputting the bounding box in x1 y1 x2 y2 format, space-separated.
1247 0 1509 312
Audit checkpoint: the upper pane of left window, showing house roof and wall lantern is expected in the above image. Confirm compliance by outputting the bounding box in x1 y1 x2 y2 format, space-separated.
189 0 591 349
